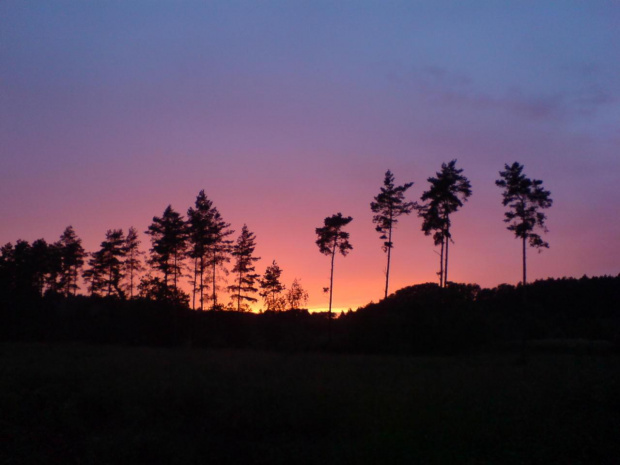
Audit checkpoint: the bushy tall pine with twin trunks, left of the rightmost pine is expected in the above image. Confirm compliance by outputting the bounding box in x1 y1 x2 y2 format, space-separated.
418 160 472 287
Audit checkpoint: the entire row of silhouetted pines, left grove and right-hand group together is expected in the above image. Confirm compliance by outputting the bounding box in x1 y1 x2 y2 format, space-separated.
0 160 552 314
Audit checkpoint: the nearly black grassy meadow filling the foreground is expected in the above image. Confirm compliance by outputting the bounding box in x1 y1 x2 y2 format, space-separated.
0 344 620 464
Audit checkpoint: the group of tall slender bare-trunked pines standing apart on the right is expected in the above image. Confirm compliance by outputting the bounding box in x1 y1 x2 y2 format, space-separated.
316 160 553 314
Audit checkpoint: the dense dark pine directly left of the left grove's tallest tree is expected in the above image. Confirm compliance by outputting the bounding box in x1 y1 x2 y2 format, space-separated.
146 205 187 290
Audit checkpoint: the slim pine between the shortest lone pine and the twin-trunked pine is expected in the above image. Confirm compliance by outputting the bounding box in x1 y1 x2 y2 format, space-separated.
370 170 415 298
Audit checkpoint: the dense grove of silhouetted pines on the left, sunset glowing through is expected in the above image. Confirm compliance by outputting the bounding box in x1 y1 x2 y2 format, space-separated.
0 190 308 311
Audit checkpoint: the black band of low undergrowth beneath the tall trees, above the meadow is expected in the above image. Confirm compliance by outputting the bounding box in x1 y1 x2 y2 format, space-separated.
0 275 620 354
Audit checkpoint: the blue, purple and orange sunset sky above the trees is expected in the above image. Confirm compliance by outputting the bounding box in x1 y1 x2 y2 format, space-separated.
0 0 620 309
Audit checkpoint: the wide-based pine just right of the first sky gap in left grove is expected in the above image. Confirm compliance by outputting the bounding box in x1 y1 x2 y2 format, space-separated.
84 229 127 298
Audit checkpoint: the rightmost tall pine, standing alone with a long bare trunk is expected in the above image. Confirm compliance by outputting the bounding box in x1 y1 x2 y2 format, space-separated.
495 162 553 286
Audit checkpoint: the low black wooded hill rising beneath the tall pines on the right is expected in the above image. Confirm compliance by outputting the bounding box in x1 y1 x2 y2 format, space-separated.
345 276 620 352
